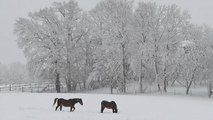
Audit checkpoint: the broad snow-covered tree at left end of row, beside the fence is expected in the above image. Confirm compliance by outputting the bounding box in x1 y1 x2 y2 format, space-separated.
15 0 87 92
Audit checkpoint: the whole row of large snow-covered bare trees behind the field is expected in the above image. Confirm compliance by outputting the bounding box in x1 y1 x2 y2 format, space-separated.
14 0 213 94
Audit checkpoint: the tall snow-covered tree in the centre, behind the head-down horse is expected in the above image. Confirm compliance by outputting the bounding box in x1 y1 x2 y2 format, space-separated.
92 0 133 93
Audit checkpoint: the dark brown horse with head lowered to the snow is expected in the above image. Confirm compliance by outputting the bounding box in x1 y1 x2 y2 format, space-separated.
101 100 118 113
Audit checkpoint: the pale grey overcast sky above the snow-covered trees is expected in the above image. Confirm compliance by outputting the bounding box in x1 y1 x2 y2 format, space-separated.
0 0 213 64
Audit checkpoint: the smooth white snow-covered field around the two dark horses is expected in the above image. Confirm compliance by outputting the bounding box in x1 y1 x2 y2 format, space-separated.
0 93 213 120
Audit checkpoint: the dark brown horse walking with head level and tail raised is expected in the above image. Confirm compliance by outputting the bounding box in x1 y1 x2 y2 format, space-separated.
53 98 83 112
